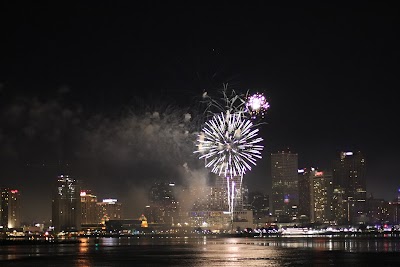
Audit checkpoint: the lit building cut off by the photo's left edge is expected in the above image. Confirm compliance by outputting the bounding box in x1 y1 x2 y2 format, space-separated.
0 188 21 229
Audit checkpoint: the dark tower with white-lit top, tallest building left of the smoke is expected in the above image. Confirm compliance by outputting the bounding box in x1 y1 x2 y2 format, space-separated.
52 175 82 233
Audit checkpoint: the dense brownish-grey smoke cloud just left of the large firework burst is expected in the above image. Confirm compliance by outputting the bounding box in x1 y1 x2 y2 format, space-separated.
82 104 203 184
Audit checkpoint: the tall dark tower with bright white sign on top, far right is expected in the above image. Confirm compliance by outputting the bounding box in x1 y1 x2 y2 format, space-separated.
333 151 367 224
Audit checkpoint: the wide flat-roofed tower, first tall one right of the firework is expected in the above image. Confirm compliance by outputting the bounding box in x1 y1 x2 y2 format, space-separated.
271 151 299 221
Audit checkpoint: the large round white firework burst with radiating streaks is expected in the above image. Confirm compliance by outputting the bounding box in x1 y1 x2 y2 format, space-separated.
195 111 264 177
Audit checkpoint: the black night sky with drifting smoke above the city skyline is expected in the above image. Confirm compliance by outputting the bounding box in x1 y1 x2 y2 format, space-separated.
0 1 400 222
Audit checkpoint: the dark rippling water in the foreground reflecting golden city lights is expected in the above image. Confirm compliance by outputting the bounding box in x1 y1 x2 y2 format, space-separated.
0 237 400 267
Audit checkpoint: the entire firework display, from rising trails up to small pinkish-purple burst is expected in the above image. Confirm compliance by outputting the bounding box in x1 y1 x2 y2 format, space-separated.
194 86 269 222
